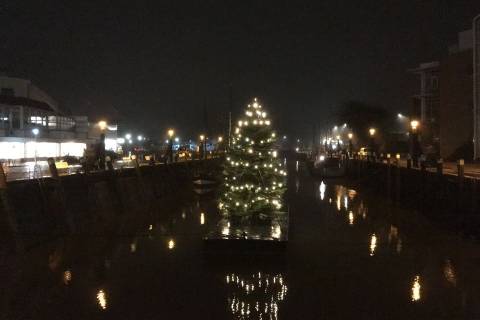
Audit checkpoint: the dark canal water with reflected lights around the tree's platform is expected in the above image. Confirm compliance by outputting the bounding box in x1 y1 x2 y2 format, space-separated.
0 164 480 319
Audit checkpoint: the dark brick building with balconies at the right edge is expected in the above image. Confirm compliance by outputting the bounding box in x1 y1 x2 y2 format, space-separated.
410 26 478 160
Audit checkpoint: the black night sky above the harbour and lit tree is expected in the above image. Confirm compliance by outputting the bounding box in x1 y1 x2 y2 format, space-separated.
0 0 480 137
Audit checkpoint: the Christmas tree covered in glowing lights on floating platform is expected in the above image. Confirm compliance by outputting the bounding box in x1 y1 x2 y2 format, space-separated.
219 99 287 216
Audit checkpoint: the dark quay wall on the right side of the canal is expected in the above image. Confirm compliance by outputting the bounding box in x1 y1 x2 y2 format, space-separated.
346 159 480 235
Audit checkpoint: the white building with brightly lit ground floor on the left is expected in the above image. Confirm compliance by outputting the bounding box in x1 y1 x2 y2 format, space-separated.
0 76 117 160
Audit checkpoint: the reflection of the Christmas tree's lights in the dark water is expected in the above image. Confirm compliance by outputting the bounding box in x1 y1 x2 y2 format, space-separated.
225 272 288 319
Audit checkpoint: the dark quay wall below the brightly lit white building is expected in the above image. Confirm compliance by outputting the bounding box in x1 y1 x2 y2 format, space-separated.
0 159 221 255
